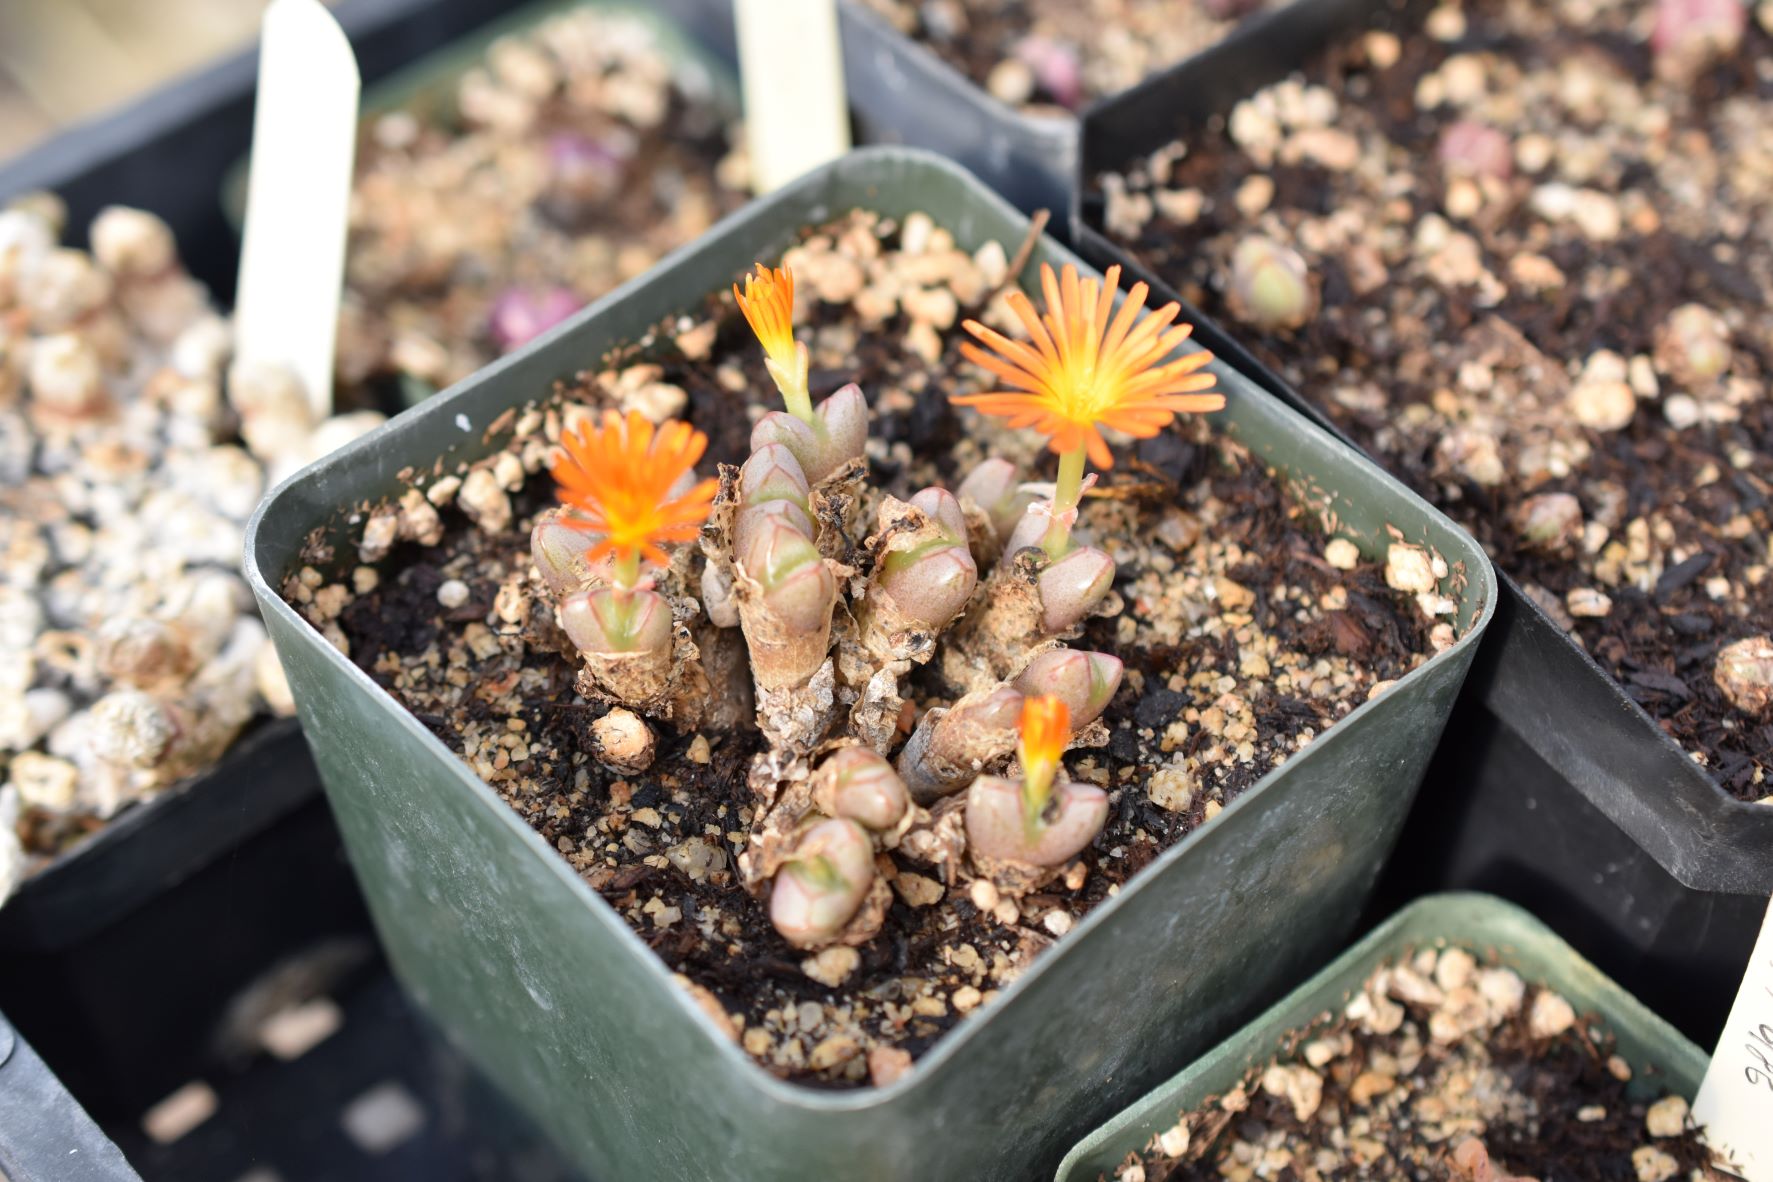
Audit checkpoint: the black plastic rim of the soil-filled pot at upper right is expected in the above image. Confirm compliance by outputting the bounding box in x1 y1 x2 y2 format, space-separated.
1071 0 1773 895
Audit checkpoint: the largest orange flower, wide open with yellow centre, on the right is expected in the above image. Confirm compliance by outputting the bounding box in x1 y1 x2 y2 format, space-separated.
954 264 1225 468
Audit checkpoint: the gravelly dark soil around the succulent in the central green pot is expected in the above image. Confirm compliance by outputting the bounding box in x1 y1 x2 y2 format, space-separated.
284 211 1456 1085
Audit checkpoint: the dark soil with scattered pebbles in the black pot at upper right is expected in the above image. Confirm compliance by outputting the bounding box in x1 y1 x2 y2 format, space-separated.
1101 0 1773 799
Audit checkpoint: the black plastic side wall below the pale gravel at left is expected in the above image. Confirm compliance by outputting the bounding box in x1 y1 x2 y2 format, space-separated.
0 719 372 1116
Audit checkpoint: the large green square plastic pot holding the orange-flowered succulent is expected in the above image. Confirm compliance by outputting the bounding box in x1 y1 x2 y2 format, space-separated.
248 149 1495 1180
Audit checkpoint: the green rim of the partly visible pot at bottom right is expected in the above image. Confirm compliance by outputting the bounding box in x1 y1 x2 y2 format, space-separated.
1055 891 1707 1182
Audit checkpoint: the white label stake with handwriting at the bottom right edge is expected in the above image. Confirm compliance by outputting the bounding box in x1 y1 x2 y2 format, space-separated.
1693 904 1773 1182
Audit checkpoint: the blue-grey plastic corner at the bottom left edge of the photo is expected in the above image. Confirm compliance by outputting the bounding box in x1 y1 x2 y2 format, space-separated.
0 1015 140 1182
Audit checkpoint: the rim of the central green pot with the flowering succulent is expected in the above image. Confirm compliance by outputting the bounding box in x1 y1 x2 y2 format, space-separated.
246 147 1496 1113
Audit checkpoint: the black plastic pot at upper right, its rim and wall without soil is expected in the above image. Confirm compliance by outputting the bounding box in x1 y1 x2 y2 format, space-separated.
1073 0 1773 1044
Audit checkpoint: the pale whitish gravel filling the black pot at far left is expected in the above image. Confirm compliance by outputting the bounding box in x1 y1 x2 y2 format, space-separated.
0 195 381 898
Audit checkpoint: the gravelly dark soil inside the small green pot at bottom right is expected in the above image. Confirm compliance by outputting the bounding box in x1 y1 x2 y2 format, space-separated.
1103 946 1723 1182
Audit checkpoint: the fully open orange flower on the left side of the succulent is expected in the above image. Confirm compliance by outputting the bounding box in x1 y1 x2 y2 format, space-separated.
553 411 720 565
